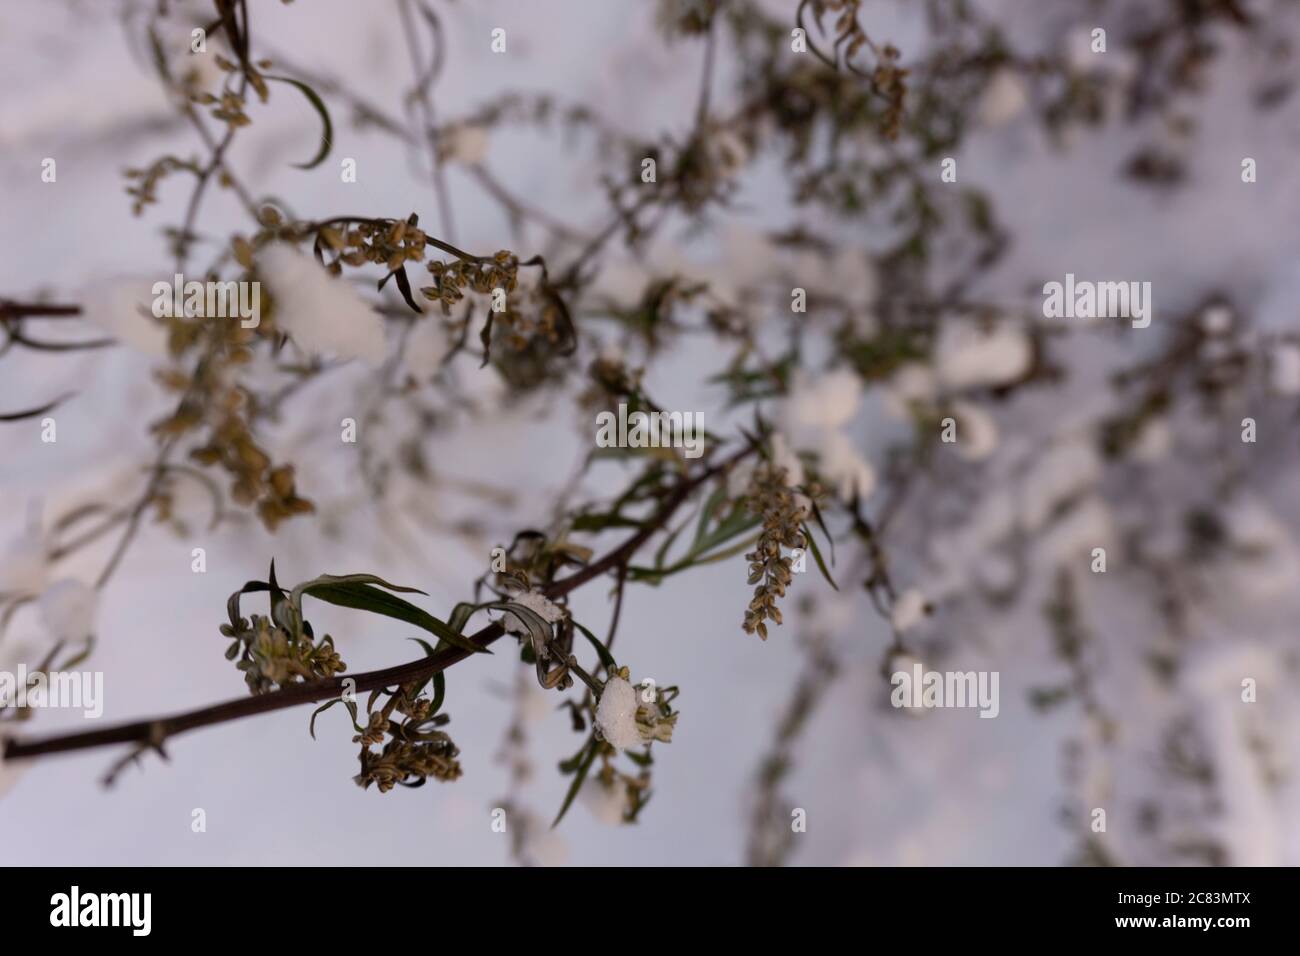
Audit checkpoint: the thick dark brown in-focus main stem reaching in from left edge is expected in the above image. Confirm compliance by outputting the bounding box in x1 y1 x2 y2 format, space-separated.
4 445 754 760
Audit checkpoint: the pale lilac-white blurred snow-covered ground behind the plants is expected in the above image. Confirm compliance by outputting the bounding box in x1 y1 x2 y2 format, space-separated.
0 0 1300 866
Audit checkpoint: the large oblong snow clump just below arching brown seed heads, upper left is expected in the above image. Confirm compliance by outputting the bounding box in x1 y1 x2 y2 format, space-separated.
257 243 385 365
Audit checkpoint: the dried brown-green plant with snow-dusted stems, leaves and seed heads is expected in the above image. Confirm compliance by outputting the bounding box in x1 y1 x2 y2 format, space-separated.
0 0 1300 864
